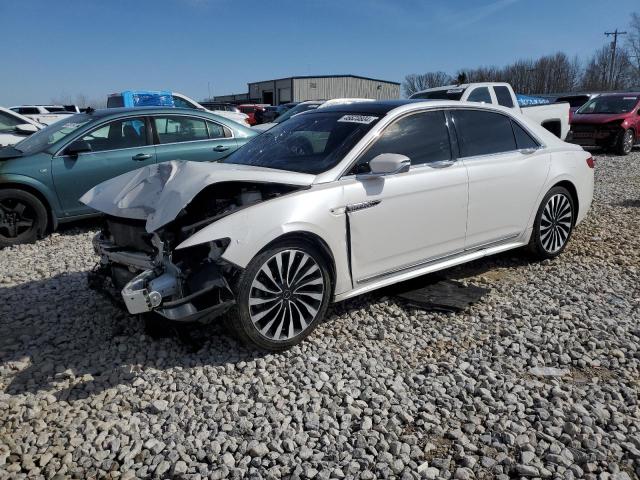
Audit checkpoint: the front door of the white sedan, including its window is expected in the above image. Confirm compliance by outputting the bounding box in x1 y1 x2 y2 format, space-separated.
343 111 468 286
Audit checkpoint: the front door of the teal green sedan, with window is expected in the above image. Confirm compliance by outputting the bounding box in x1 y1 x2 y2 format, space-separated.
52 116 156 217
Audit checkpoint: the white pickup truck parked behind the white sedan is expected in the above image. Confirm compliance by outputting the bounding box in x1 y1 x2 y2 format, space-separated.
409 82 570 140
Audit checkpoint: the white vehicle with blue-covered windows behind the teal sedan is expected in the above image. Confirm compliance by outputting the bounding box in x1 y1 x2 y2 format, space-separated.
107 90 249 127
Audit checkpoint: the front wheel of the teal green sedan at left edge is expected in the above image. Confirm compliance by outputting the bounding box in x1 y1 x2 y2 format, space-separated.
0 188 48 247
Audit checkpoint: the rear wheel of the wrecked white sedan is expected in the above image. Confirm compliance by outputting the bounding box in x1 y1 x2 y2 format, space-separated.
528 187 576 260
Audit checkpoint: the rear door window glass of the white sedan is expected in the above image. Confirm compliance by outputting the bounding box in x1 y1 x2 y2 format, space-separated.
451 110 517 157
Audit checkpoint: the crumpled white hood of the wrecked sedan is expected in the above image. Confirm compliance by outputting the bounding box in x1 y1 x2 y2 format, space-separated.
80 160 315 232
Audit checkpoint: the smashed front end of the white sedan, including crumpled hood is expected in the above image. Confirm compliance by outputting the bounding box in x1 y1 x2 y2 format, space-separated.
81 162 308 322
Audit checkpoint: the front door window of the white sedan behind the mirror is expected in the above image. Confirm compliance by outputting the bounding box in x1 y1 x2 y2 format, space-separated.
352 110 452 174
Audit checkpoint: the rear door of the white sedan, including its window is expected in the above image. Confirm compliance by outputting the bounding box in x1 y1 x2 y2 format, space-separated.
451 109 550 249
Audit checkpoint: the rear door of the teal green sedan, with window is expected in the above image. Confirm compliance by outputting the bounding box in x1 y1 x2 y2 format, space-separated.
151 114 237 162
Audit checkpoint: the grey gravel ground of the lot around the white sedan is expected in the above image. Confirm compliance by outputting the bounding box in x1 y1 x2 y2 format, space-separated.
0 150 640 479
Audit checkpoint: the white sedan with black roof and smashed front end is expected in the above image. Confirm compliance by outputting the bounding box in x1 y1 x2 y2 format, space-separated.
81 100 594 350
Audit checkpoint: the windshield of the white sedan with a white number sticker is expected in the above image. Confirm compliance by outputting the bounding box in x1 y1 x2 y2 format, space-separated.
224 112 379 175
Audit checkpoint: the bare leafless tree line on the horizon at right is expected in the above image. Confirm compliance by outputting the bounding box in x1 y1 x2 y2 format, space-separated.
402 13 640 96
